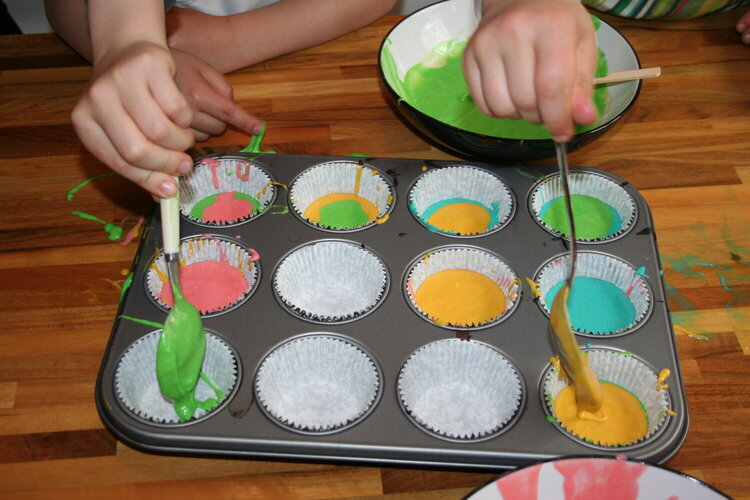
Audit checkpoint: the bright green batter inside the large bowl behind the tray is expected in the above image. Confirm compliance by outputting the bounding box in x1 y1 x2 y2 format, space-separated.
382 18 609 139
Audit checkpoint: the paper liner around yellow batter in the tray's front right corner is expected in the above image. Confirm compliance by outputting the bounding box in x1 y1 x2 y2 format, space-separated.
541 347 669 449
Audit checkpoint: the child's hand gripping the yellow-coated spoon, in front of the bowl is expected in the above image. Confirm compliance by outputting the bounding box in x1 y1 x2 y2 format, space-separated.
463 0 596 142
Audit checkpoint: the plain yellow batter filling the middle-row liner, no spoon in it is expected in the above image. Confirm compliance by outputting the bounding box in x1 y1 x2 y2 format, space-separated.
414 269 506 326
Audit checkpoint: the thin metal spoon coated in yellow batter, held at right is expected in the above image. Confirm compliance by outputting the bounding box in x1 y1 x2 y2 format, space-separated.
547 142 603 416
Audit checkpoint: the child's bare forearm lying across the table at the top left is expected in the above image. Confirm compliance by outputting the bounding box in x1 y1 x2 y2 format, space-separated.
167 0 395 73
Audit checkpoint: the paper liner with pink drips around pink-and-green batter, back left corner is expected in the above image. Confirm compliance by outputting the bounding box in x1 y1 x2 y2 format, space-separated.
180 155 276 227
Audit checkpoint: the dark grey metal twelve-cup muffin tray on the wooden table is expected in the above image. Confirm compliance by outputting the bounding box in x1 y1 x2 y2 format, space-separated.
96 153 688 470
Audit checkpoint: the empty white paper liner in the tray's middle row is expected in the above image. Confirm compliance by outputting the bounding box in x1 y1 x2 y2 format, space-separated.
273 240 389 323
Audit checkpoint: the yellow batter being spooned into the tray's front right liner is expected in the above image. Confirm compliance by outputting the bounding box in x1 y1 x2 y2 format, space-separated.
554 381 648 446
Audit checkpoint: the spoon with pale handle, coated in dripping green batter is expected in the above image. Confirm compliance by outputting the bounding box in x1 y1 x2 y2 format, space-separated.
156 180 216 421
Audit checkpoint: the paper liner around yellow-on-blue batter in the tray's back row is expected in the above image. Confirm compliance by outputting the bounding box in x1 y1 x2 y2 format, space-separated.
409 165 515 237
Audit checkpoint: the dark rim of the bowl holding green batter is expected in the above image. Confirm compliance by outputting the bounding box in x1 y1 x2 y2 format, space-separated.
378 0 643 145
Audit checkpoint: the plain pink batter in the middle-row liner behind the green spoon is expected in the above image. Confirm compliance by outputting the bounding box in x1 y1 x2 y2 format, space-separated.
159 259 248 314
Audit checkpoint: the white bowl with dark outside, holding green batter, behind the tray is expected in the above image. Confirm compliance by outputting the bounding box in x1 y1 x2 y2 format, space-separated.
378 0 641 162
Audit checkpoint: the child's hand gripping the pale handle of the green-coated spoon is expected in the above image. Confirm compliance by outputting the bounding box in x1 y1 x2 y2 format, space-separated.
72 42 193 197
